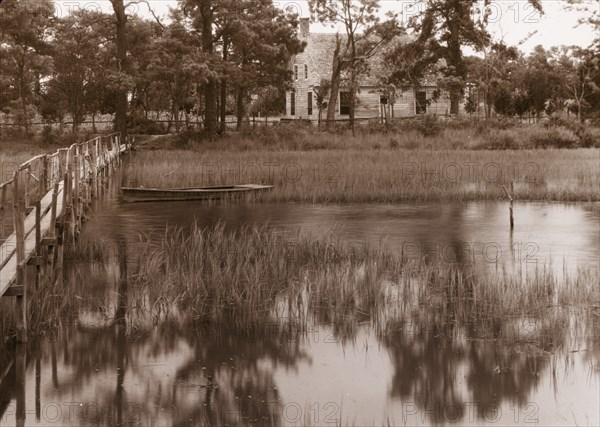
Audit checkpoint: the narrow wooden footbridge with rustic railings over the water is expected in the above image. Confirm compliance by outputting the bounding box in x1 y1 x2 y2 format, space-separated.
0 133 131 342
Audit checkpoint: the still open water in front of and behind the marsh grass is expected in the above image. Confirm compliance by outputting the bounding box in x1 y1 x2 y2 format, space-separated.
0 192 600 426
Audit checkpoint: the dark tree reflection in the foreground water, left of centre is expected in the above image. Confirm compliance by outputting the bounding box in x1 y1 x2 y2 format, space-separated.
174 324 307 425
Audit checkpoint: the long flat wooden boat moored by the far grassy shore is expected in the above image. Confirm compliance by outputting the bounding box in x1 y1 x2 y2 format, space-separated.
121 184 273 202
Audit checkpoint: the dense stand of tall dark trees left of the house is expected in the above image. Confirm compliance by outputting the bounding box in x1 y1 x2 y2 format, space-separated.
0 0 304 134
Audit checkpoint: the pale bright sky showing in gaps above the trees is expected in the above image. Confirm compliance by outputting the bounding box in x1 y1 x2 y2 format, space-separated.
55 0 600 52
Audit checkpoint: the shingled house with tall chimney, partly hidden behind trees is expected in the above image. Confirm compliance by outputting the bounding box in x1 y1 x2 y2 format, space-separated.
285 18 450 121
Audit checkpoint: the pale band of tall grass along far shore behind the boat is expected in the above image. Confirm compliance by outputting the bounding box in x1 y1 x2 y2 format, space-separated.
123 149 600 203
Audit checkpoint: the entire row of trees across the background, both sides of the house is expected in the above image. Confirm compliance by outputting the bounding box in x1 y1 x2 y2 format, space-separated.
0 0 600 137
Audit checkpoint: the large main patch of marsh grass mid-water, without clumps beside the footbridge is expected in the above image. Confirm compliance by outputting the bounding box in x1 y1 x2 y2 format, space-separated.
124 225 600 337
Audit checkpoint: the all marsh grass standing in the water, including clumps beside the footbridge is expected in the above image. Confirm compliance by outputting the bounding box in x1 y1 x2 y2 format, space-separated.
0 224 600 351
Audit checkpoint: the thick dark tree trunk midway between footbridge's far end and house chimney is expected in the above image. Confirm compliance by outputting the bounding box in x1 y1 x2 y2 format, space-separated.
200 0 217 139
